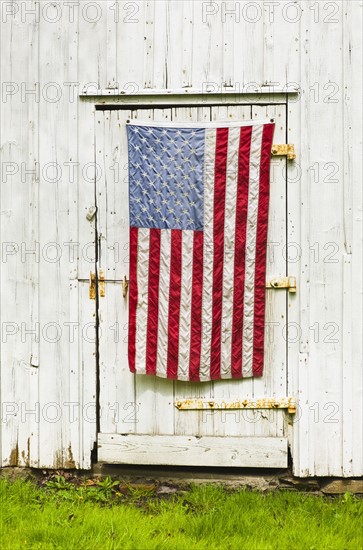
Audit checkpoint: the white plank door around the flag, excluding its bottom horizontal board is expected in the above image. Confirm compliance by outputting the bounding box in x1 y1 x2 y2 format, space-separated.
96 105 287 458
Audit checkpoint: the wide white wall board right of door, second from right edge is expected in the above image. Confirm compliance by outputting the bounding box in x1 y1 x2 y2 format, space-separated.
299 4 343 475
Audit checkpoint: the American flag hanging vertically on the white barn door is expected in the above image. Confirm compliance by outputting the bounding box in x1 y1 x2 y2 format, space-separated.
127 121 274 381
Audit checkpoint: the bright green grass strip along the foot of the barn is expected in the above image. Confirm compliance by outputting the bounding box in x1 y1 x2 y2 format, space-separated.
0 477 363 550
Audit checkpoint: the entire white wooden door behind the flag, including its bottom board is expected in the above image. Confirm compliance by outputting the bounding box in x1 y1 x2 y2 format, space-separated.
95 104 288 467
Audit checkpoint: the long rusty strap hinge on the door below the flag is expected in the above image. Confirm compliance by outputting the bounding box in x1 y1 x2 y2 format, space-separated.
174 397 296 414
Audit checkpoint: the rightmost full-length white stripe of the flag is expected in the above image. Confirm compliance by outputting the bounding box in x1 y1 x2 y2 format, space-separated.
242 126 263 376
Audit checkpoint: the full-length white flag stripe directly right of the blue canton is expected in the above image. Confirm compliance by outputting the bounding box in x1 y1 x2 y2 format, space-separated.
200 130 216 382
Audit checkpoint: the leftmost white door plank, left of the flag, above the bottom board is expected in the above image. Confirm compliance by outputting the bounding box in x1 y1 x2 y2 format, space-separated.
95 111 137 433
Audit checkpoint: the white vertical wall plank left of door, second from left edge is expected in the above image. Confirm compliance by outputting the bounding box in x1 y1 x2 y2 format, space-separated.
38 2 78 468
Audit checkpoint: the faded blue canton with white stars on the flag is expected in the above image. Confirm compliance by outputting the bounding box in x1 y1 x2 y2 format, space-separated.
127 124 205 231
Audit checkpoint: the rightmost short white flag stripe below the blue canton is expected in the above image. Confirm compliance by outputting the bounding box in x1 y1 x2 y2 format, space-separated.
178 230 195 380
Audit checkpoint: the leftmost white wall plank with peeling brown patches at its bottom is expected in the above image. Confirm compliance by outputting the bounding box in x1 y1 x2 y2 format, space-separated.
0 2 39 466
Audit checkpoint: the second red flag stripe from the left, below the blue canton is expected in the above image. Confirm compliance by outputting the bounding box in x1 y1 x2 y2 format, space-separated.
146 229 161 374
